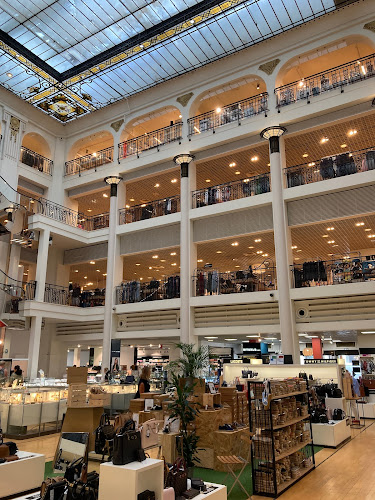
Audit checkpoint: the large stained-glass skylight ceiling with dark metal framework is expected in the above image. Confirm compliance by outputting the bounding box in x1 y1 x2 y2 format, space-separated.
0 0 357 122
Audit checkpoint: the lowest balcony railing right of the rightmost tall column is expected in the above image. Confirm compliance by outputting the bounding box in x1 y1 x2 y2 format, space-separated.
292 257 375 288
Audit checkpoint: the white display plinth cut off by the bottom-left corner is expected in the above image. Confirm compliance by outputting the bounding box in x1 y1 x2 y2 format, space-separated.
0 451 45 498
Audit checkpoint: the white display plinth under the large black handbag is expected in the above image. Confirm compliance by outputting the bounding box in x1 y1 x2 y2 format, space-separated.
99 458 164 500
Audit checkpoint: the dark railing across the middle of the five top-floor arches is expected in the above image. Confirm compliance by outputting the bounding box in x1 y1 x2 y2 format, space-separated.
118 122 182 160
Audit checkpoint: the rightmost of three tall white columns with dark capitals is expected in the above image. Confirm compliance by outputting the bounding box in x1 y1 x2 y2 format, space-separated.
270 131 300 364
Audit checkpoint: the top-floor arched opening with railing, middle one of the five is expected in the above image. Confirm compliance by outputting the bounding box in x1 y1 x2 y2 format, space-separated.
119 106 182 159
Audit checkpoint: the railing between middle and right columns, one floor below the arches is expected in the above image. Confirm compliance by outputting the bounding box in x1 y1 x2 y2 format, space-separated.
192 173 270 208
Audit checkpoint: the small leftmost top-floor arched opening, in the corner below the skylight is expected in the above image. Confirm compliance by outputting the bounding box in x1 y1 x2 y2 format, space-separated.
20 132 53 174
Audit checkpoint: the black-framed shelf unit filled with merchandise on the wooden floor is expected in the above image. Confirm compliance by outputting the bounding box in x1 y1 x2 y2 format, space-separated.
248 378 315 498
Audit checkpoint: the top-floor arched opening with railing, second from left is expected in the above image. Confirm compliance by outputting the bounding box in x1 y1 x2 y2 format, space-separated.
65 130 114 175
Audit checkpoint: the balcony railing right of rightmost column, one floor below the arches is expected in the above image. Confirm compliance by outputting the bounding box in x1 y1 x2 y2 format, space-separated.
284 147 375 188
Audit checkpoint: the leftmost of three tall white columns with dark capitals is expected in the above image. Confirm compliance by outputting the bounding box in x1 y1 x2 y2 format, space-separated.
102 179 121 380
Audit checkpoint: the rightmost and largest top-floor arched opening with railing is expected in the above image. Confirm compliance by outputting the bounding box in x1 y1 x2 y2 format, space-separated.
276 36 375 106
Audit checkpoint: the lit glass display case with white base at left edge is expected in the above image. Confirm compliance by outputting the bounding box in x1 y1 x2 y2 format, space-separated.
0 381 68 438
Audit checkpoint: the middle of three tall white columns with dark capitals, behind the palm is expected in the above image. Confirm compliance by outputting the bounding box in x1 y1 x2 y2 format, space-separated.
180 158 197 344
